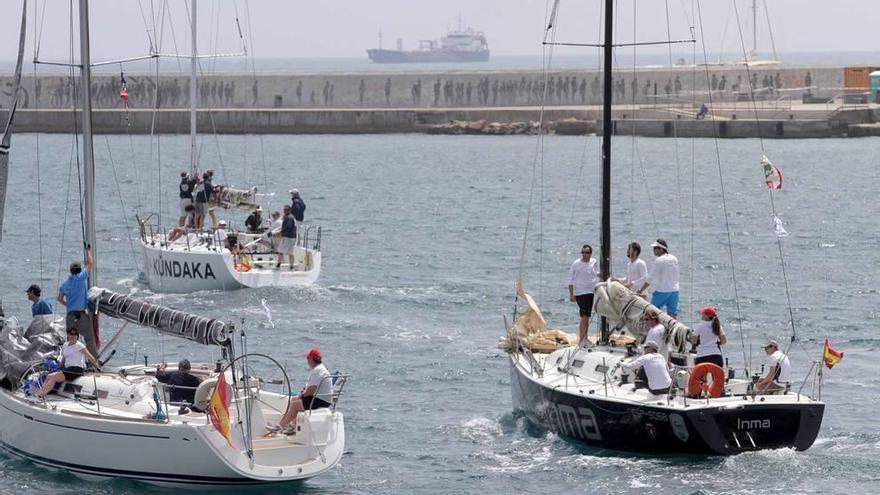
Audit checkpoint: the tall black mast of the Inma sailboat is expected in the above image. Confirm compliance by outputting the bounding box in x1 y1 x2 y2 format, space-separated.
599 0 614 340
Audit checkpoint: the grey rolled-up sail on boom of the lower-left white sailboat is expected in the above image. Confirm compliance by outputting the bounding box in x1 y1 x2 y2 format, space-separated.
89 287 232 346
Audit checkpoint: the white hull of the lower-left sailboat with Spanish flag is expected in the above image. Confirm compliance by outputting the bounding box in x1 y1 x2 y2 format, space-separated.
0 378 345 486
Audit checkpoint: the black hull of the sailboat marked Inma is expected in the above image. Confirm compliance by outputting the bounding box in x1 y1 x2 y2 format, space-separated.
510 359 825 455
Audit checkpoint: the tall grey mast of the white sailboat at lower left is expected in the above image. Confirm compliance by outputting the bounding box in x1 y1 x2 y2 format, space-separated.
79 0 98 286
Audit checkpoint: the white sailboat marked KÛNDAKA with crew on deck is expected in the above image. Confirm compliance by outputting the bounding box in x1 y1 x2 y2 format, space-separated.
138 0 322 293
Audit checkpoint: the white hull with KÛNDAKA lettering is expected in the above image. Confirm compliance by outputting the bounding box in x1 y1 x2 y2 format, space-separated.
141 242 321 294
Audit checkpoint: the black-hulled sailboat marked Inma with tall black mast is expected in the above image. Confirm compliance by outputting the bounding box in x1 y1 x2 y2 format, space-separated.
502 0 825 455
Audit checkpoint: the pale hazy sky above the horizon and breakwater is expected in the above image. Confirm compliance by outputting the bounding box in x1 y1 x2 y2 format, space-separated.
0 0 880 60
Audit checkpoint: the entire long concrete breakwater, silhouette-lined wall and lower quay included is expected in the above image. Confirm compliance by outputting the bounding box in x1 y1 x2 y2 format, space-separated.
0 66 874 137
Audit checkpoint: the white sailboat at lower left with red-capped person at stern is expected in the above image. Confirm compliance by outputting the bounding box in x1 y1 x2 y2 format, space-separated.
0 0 346 486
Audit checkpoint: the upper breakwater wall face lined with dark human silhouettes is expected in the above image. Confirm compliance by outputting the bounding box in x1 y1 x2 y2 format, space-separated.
0 66 843 109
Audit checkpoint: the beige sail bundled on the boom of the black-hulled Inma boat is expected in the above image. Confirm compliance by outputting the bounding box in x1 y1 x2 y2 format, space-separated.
594 281 691 352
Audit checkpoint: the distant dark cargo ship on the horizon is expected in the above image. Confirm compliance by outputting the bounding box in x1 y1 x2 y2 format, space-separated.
367 27 489 64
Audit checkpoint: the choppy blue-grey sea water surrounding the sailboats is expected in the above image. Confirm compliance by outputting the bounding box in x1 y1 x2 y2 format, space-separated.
0 135 880 494
